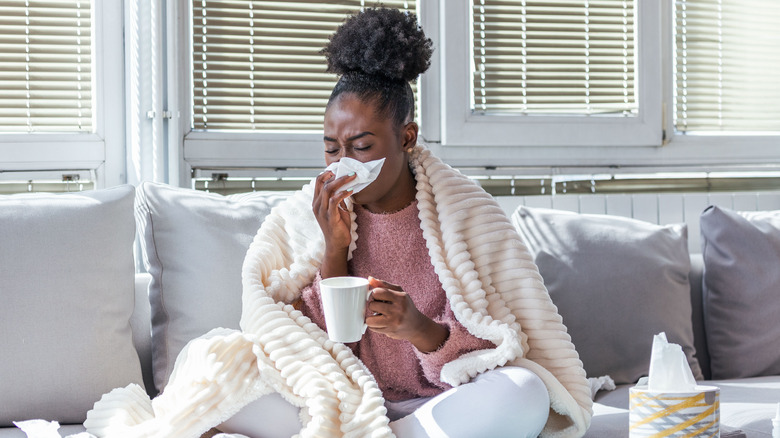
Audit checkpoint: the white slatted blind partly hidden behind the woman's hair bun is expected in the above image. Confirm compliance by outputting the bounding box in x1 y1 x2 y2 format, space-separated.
192 0 416 131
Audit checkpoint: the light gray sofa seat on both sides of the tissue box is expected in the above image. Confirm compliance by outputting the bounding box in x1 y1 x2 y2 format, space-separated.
585 376 780 438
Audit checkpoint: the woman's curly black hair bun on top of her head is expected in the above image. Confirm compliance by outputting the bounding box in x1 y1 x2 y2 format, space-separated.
321 7 433 82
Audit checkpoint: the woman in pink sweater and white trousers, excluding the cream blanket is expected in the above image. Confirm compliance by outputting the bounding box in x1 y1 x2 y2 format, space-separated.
230 8 588 437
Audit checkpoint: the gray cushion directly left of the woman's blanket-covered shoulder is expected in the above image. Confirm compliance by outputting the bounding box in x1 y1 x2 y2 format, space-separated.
136 182 287 391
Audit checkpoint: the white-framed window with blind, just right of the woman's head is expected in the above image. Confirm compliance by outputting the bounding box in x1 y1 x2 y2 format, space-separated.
441 0 662 152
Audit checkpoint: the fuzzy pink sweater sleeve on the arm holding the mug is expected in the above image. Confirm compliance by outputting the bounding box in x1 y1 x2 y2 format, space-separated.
415 306 496 389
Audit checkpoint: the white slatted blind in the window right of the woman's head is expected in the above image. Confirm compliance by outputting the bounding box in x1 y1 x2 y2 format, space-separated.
471 0 638 116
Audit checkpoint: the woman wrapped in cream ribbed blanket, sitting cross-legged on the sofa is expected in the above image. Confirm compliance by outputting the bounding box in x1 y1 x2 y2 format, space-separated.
85 8 591 437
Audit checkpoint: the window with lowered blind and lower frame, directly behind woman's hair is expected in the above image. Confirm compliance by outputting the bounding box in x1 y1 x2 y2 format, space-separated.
182 0 417 173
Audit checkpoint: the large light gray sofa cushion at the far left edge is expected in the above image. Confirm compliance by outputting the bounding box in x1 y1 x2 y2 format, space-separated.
0 186 143 426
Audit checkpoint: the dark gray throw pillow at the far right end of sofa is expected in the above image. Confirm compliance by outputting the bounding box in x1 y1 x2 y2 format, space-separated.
700 206 780 379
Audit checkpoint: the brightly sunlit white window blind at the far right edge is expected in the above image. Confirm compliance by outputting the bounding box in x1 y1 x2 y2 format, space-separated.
675 0 780 132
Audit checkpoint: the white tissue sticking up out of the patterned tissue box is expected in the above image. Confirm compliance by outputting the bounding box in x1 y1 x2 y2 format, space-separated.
647 332 696 392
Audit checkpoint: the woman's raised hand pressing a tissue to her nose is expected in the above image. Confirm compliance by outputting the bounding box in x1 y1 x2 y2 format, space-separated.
312 171 356 255
